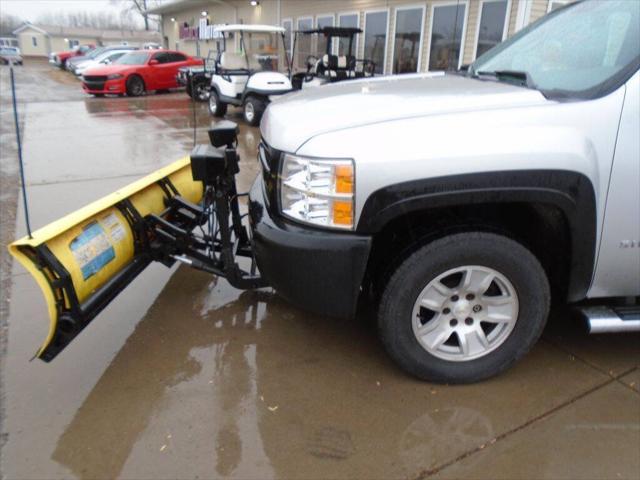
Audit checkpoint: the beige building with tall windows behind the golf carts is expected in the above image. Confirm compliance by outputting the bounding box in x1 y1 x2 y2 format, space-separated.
149 0 571 74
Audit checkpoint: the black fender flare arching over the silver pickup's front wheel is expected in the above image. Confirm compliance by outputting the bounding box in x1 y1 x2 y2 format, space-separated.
357 170 597 300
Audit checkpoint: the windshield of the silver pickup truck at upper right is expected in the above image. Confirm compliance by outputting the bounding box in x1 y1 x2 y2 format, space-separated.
469 0 640 98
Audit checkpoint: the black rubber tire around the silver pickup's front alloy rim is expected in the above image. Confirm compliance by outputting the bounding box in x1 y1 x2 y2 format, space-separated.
378 232 551 383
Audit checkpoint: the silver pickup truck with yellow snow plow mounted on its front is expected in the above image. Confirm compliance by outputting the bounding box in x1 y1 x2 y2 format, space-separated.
10 0 640 383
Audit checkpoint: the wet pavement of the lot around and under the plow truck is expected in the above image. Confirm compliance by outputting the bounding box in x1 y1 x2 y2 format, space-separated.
0 61 640 479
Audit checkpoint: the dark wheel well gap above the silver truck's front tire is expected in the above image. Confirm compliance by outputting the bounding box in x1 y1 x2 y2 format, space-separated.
365 203 571 300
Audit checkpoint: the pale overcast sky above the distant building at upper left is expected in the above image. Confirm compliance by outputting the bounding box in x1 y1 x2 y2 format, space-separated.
0 0 160 22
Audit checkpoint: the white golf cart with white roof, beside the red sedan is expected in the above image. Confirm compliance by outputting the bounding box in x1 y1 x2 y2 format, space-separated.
209 25 292 126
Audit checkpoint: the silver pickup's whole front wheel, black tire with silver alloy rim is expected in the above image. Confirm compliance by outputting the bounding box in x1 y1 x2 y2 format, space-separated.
378 232 550 383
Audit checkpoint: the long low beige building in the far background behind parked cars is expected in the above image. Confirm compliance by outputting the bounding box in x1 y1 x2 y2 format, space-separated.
13 23 161 57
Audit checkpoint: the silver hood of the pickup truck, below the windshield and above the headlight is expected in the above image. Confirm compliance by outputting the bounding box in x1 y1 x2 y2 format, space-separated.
261 73 548 152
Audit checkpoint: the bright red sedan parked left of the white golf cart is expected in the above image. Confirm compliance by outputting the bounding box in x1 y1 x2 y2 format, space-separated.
82 50 202 97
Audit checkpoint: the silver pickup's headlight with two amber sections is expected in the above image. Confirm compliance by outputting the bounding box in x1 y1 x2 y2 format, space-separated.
280 154 355 230
